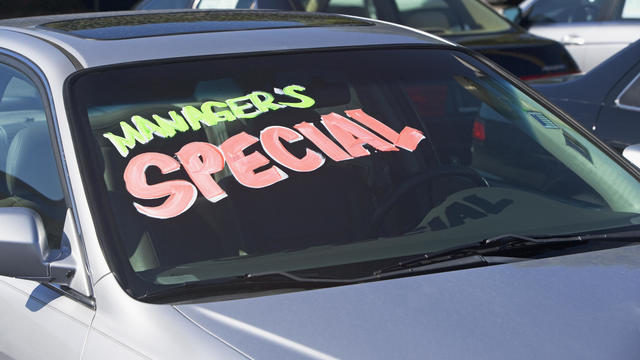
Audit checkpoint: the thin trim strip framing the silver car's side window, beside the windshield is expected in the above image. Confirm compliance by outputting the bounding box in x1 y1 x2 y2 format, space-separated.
0 48 94 303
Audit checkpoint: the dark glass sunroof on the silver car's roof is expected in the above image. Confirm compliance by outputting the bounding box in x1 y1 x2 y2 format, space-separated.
40 11 371 40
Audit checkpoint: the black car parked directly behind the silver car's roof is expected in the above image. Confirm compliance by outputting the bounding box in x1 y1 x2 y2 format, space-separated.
136 0 579 80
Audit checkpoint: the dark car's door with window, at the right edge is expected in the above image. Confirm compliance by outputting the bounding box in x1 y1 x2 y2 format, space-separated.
595 62 640 152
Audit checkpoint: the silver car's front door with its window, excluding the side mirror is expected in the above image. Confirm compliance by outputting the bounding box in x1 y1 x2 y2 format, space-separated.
0 55 94 360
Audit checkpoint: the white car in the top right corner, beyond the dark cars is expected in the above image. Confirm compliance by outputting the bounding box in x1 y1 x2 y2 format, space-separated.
504 0 640 72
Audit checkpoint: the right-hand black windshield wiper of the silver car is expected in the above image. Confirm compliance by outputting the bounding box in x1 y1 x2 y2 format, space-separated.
373 230 640 276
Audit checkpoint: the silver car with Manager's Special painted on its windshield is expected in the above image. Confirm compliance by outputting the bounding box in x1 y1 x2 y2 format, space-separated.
0 11 640 360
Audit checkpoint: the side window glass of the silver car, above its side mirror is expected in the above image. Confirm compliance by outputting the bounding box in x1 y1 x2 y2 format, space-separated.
0 64 66 248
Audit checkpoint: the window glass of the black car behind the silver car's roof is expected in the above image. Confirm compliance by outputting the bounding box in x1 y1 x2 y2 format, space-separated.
302 0 512 35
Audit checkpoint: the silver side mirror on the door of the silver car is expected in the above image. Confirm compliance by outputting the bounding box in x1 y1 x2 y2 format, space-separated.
0 207 75 285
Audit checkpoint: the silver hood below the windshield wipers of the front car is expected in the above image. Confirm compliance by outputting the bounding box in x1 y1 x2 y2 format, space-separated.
176 246 640 359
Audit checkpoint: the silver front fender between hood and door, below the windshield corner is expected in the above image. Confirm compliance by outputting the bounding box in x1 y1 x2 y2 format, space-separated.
84 274 247 359
